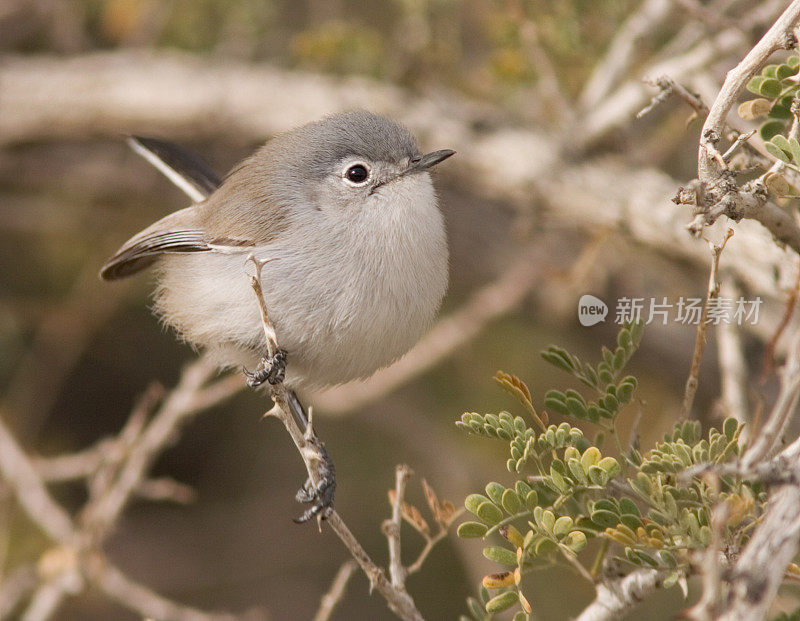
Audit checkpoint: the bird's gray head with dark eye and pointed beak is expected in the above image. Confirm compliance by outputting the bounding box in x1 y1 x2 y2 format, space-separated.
257 110 454 213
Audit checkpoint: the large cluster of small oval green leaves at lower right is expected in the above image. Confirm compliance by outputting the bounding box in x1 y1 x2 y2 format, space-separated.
456 322 765 620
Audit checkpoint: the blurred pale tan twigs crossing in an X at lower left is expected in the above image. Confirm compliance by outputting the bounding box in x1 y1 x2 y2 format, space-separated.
0 344 247 621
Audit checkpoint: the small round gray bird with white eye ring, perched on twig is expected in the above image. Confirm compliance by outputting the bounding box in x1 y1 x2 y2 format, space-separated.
100 110 454 387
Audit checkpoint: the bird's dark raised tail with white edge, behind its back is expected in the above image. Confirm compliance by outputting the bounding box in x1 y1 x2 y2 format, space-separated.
128 136 222 203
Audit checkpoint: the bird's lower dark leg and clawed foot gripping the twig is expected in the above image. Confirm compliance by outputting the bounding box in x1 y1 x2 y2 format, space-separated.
287 390 336 524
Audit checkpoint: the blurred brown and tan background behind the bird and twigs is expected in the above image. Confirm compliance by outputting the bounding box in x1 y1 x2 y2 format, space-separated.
0 0 797 619
